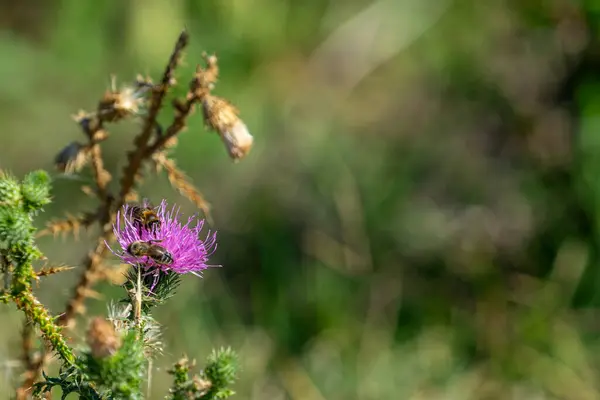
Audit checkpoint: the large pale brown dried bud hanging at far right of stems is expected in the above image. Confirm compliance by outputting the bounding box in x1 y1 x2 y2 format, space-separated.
202 95 254 161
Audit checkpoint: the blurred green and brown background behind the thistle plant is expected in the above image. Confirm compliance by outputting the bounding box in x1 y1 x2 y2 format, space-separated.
0 0 600 400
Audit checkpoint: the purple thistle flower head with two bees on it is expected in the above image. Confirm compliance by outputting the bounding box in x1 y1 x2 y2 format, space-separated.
109 200 217 276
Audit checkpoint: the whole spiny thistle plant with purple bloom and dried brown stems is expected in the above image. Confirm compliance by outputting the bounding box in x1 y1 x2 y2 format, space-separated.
0 31 246 400
